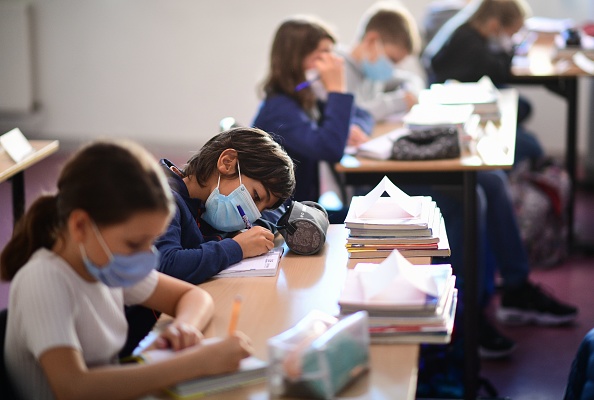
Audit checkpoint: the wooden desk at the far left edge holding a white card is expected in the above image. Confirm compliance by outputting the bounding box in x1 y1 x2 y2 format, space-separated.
0 140 59 223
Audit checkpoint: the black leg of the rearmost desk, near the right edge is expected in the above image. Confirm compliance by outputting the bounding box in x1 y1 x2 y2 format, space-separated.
564 78 578 247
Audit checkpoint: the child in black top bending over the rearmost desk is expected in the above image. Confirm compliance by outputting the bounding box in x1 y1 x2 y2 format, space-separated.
422 0 542 130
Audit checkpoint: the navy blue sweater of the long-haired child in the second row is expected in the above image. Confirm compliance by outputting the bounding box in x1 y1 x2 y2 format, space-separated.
253 93 373 201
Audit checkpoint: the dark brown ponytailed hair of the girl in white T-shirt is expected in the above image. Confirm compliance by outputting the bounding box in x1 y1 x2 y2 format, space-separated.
0 141 175 280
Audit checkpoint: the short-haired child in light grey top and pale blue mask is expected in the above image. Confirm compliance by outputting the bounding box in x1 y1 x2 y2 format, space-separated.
337 2 425 122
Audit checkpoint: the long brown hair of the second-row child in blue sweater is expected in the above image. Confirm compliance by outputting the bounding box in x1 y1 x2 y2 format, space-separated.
263 17 336 110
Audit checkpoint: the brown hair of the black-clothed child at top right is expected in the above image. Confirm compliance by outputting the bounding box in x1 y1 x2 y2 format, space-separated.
468 0 530 27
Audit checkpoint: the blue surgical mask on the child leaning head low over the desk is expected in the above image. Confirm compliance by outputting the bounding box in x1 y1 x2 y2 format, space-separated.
202 162 262 232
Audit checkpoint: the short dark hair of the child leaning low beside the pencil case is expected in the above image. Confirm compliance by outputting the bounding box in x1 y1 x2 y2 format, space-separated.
183 128 295 208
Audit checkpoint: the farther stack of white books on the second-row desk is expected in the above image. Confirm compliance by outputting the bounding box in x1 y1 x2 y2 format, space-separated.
419 76 501 121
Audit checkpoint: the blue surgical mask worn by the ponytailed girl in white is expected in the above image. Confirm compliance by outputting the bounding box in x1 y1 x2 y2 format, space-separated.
78 222 159 287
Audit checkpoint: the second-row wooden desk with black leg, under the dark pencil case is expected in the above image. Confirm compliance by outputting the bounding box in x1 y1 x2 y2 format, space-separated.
335 89 518 399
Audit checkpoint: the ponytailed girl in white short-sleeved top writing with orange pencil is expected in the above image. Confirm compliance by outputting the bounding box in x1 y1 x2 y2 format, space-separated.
0 141 250 399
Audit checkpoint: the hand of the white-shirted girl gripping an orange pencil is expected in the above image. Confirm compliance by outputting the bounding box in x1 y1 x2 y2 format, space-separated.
202 331 253 374
